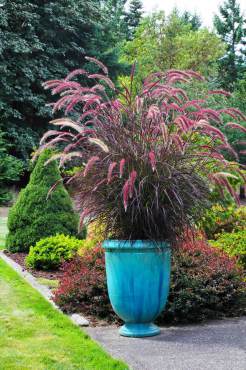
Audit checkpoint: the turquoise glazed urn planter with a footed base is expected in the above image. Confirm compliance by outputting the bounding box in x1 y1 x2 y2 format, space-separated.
103 240 171 337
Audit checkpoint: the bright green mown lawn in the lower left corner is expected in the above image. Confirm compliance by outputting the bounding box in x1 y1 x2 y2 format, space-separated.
0 220 128 370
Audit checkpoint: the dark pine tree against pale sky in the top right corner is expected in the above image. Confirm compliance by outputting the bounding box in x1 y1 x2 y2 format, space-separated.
214 0 246 90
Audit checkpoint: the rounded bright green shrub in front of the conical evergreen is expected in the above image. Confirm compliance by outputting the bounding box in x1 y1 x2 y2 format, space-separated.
26 234 81 270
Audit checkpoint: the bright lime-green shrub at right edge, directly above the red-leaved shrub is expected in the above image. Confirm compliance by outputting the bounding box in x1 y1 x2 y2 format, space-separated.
210 229 246 269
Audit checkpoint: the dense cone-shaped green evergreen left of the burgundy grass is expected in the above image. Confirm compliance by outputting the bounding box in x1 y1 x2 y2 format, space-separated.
6 150 78 252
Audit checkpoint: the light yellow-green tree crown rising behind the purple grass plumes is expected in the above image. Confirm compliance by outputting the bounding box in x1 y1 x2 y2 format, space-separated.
121 10 225 85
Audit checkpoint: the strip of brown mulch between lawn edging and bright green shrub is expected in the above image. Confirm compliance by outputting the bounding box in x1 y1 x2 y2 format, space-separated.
4 251 63 280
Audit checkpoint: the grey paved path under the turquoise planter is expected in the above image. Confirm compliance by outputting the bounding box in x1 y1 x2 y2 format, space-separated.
86 318 246 370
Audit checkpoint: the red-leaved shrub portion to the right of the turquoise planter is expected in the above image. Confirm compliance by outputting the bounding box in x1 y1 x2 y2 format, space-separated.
158 239 246 323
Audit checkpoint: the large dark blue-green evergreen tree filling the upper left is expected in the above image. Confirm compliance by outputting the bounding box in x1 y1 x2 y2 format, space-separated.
0 0 123 168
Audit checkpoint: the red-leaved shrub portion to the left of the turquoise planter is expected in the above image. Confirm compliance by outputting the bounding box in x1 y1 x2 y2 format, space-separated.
54 246 116 321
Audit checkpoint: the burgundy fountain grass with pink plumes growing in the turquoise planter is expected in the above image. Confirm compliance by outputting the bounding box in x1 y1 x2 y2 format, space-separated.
40 58 243 240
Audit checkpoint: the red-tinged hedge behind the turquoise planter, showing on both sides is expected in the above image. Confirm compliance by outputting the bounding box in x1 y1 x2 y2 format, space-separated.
54 240 245 323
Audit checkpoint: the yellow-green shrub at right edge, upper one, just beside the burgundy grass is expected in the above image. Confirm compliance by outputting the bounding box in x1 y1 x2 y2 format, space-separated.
199 204 246 239
